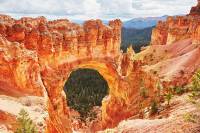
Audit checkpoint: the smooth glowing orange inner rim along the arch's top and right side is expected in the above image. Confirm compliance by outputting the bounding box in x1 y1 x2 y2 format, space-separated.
62 60 123 130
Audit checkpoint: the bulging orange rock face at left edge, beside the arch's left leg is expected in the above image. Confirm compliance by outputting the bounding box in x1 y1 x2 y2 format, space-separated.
0 36 43 96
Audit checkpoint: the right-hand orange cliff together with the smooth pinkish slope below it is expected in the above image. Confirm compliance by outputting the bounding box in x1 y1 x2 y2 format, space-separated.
134 1 200 86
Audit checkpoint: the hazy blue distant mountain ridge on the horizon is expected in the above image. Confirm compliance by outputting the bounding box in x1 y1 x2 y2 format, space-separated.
123 15 168 29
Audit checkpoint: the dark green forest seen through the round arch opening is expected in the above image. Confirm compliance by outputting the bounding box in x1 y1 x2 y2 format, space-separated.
64 69 108 121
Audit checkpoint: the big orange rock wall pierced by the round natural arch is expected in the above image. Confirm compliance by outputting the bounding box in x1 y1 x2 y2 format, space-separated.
0 15 156 133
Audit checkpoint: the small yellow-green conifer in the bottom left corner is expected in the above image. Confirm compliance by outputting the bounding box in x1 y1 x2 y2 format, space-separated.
15 109 38 133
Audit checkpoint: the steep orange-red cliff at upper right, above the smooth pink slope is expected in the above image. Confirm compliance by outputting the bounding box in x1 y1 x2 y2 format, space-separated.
151 1 200 45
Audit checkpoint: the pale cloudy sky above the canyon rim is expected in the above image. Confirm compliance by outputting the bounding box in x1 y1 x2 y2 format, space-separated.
0 0 197 20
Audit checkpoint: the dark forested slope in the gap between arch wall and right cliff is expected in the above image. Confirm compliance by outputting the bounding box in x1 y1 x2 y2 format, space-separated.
121 27 154 53
